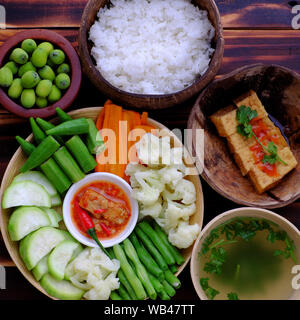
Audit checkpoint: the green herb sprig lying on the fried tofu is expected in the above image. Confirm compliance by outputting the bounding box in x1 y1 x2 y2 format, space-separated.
236 106 287 166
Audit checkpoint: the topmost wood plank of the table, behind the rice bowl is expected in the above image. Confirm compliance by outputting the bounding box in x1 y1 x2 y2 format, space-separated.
1 0 299 29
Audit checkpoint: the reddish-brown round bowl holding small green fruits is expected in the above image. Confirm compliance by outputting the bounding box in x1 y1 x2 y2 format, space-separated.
0 29 82 118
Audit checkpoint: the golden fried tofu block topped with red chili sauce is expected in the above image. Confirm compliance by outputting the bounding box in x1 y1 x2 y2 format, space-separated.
211 90 297 194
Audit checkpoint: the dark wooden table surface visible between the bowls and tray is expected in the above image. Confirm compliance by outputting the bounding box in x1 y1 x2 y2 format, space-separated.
0 0 300 300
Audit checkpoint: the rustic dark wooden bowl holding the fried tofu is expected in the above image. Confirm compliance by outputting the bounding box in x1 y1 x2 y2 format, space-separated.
188 64 300 208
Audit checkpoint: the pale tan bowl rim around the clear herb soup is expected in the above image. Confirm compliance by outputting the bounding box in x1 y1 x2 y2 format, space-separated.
190 208 300 300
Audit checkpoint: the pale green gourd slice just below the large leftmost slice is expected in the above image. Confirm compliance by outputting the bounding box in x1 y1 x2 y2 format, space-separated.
8 207 51 241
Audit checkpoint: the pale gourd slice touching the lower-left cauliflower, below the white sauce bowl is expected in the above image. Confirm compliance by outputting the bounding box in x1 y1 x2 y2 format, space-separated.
48 240 81 280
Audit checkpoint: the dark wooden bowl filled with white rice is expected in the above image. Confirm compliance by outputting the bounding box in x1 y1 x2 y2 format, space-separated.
78 0 224 109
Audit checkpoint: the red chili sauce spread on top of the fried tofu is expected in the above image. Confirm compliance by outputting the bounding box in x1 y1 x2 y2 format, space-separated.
250 118 280 177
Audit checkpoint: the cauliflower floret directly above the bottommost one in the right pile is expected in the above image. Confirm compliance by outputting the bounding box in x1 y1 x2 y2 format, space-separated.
157 200 196 232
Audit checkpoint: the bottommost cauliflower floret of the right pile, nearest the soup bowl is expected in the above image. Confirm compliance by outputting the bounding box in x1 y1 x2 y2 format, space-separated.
168 221 200 249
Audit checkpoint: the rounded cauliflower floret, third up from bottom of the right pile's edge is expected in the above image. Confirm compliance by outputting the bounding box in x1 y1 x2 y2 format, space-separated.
163 179 196 204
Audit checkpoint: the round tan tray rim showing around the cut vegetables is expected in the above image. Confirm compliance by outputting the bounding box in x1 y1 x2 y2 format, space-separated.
0 107 204 298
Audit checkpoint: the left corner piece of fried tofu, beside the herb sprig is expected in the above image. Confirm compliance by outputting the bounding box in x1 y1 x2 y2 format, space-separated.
210 105 238 137
